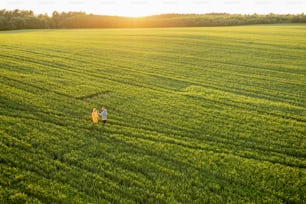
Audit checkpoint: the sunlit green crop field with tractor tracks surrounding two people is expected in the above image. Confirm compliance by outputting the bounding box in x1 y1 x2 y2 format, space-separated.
0 24 306 203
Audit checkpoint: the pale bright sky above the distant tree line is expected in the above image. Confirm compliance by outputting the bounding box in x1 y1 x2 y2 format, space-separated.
0 0 306 17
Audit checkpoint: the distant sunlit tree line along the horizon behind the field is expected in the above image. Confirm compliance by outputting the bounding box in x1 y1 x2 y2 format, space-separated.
0 9 306 30
